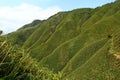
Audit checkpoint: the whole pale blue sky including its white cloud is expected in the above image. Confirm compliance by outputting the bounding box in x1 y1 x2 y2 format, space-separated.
0 0 115 34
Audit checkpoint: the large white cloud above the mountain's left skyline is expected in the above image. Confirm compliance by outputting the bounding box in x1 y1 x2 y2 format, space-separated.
0 3 62 33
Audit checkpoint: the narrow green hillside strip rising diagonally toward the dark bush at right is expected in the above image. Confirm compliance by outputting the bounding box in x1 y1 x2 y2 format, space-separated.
62 39 107 75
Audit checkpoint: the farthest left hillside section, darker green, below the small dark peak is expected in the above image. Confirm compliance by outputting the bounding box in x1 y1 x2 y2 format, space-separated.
7 20 42 46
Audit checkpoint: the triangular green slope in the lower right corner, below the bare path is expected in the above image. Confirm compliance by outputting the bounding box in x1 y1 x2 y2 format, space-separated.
67 41 120 80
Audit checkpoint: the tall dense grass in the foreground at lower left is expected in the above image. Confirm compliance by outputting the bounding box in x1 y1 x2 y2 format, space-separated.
0 37 61 80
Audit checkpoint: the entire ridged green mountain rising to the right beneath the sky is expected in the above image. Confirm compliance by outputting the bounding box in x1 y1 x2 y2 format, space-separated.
7 0 120 80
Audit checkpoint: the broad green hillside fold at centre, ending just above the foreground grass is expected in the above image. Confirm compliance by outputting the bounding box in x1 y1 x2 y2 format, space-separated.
40 35 87 72
